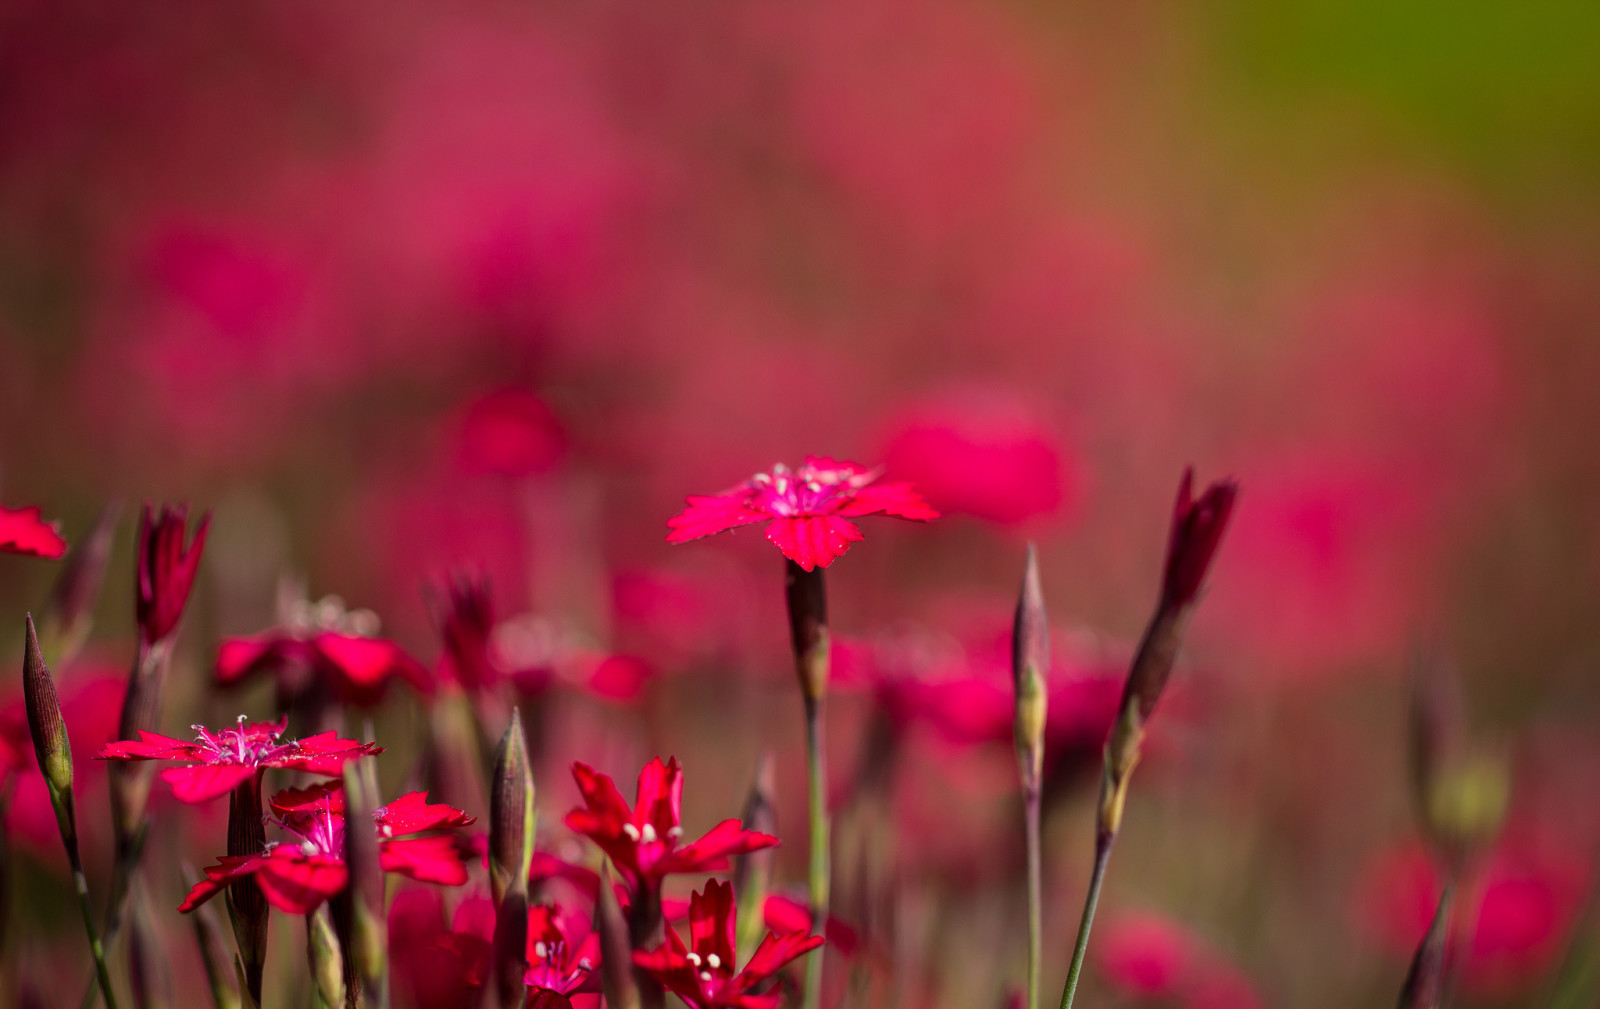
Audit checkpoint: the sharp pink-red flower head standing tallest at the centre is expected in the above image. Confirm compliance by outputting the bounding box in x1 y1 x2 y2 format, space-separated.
667 456 939 571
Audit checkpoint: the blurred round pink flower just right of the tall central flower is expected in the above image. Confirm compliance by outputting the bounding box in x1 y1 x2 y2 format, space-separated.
883 390 1080 526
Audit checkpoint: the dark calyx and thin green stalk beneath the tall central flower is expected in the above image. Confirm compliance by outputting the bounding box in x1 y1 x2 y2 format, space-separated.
784 560 832 1009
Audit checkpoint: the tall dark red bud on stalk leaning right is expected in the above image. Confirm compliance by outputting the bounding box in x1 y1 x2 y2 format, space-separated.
1061 469 1238 1009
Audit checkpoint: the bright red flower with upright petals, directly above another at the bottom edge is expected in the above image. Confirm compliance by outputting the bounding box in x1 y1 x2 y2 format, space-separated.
566 756 778 889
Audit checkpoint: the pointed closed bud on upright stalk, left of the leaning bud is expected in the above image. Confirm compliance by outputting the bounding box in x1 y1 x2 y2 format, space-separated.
1011 544 1050 1009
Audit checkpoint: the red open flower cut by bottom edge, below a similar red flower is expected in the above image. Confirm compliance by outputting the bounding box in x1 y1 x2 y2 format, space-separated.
634 879 822 1009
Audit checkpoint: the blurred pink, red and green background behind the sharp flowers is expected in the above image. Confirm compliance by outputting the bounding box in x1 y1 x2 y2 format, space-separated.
0 0 1600 1009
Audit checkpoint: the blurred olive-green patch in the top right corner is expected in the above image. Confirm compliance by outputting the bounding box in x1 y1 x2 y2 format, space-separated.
1194 0 1600 174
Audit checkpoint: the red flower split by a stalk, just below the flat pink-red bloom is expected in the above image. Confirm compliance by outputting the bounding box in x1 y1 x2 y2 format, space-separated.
178 782 477 915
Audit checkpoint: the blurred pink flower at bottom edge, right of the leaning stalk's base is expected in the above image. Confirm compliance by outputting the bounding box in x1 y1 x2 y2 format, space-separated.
1091 913 1261 1009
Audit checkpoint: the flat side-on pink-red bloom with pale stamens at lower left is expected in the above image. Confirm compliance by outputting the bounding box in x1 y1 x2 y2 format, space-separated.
99 715 384 803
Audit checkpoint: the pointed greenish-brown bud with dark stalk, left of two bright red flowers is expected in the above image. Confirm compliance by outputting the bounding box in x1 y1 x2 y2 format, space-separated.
490 708 534 1006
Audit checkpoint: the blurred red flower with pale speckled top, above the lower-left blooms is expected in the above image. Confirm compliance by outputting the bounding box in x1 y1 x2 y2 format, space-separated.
216 596 432 707
